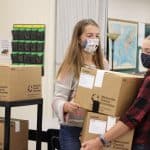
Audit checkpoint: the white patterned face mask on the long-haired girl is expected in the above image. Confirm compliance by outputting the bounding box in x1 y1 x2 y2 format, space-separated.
83 39 99 53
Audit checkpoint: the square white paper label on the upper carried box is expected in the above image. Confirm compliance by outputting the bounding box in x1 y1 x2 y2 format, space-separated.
79 73 95 89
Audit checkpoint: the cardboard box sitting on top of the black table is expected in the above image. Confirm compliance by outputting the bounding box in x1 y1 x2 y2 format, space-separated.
0 66 42 101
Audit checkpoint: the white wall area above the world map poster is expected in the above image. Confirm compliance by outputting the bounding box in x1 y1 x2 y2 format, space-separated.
108 0 150 23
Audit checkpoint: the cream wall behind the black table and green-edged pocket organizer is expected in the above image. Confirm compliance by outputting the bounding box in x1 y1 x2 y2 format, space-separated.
0 0 55 150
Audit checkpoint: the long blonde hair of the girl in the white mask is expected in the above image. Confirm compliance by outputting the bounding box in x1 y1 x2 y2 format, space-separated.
57 19 104 78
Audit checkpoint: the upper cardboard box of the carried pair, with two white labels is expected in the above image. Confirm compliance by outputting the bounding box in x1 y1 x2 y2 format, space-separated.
74 68 143 116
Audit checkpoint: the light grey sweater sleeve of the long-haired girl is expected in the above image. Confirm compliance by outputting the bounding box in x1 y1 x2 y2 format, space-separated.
52 74 73 122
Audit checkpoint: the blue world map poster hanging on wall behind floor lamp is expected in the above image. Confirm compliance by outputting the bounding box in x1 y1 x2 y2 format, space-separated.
108 19 138 70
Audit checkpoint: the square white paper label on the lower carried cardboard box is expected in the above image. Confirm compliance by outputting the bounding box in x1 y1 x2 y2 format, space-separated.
89 119 106 134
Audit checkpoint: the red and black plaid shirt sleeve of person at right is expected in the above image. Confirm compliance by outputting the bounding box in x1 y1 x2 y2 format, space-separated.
120 76 150 129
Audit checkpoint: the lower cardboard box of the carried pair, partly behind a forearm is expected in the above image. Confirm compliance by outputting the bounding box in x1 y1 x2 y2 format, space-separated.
81 112 134 150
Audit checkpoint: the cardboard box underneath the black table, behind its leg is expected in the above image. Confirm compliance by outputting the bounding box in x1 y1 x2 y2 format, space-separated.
0 119 28 150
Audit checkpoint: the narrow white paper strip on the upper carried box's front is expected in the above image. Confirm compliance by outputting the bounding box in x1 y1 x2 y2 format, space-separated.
94 70 105 87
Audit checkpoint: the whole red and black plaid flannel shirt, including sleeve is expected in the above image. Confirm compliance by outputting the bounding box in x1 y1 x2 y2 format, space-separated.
120 72 150 146
